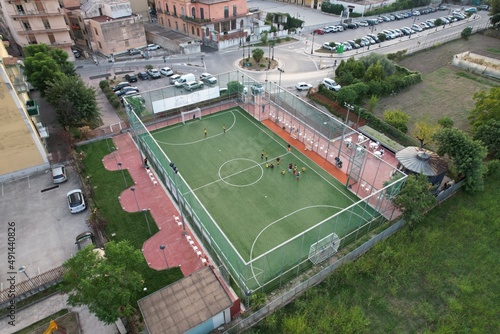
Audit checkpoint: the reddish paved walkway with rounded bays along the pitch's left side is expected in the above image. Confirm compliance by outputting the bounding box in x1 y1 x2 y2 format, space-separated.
103 133 209 276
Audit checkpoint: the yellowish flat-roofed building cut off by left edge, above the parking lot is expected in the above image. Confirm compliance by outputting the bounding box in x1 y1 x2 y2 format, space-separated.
0 38 49 183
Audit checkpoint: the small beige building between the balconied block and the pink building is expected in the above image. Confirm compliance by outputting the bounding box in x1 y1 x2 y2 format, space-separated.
63 0 147 56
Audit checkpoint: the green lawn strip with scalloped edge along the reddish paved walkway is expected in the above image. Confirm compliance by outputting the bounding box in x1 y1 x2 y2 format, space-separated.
78 139 183 298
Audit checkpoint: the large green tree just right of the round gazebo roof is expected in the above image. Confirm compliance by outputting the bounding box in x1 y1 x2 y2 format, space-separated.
434 128 487 192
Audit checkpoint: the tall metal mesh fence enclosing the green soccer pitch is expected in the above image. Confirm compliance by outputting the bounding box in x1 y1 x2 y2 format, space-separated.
126 71 406 296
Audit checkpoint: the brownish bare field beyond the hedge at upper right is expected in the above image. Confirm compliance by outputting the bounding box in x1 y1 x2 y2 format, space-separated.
374 34 500 135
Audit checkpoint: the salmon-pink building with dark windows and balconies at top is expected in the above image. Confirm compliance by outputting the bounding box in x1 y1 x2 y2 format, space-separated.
155 0 254 49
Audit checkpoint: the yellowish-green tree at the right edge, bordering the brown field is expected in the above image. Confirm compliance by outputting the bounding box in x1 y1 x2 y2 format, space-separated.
468 87 500 130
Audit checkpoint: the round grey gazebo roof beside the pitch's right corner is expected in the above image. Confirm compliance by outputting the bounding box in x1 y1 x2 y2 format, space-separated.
396 146 448 176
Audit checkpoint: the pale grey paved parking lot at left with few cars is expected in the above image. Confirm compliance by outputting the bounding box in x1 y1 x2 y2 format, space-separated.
0 167 89 289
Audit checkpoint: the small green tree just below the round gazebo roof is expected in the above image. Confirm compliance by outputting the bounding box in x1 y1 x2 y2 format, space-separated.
394 174 436 224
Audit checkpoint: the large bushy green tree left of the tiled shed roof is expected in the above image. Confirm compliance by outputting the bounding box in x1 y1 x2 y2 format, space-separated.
63 241 144 324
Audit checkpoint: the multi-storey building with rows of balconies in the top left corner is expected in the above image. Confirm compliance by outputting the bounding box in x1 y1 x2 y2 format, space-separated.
0 0 73 59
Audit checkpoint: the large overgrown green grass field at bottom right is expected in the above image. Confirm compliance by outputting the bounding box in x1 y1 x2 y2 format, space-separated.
248 171 500 333
